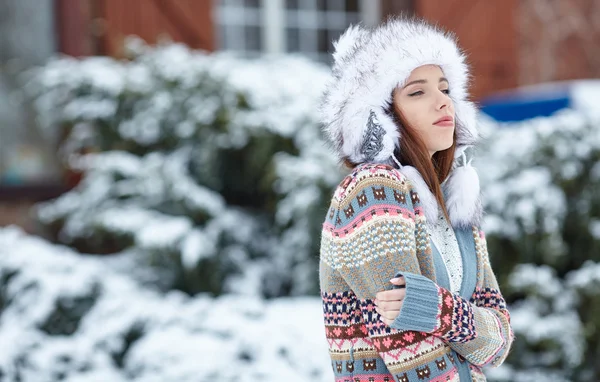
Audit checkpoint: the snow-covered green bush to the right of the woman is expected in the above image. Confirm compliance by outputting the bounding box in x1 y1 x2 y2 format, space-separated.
478 110 600 381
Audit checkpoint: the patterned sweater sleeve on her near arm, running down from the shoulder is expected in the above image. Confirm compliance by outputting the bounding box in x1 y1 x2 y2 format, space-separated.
320 168 445 378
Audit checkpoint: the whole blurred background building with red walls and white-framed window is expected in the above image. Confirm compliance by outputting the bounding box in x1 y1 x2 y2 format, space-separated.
0 0 600 230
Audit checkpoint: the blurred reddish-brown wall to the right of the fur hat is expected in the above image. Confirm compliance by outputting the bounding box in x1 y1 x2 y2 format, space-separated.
414 0 600 99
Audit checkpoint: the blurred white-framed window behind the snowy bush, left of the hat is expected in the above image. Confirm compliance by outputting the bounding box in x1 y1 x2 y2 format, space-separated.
215 0 380 63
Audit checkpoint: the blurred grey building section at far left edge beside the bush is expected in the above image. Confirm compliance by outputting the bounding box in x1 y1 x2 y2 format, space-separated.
0 0 65 231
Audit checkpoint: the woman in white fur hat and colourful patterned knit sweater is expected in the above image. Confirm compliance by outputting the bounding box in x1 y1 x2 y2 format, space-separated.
320 19 513 382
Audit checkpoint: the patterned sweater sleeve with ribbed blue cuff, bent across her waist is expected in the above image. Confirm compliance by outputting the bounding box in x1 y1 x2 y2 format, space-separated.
391 233 514 367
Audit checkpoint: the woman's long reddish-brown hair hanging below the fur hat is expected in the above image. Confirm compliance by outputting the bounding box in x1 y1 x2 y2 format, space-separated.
344 97 456 221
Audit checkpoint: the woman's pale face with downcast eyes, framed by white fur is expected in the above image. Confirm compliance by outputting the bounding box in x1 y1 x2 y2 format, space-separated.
393 65 455 156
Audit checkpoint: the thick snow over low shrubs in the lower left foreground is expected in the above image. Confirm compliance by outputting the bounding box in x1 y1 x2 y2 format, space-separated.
0 227 333 382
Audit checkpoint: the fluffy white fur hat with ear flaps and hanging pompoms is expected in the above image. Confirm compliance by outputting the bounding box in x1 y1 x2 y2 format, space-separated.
320 17 481 226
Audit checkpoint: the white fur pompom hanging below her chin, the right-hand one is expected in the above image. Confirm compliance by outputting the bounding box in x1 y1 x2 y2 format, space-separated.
443 163 483 228
